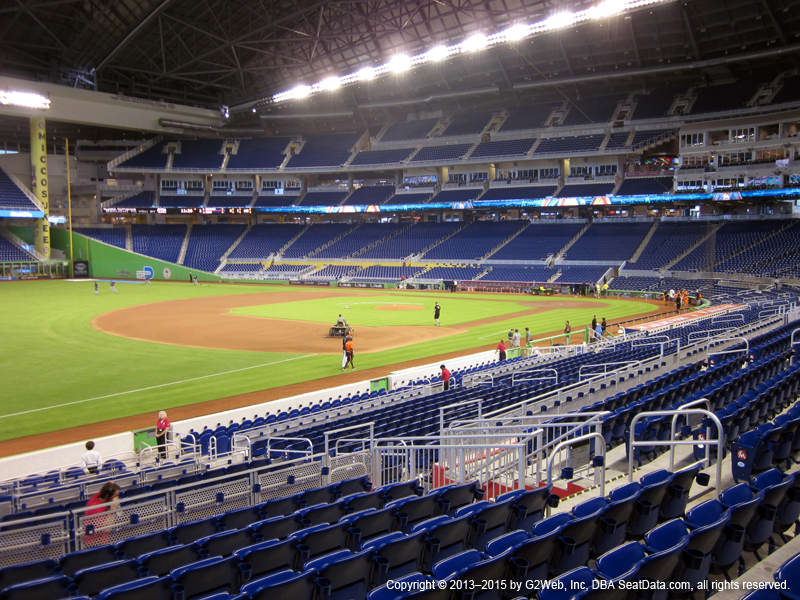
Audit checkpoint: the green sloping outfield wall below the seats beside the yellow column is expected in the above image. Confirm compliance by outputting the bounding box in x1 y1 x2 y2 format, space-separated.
50 229 220 282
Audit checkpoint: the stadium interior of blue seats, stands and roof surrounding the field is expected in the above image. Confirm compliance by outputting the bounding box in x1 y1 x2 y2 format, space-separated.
0 0 800 600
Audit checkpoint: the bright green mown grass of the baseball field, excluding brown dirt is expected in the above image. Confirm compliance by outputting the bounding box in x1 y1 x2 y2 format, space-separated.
0 281 655 440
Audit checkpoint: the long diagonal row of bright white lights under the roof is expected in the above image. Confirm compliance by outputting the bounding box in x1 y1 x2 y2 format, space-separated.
268 0 672 104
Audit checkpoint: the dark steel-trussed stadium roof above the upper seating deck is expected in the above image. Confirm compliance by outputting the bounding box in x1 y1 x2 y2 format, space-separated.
0 0 800 131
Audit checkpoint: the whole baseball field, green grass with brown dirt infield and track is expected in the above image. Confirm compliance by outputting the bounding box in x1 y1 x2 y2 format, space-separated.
0 281 664 455
